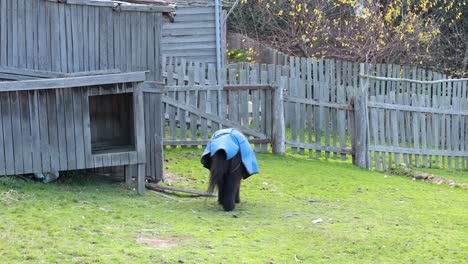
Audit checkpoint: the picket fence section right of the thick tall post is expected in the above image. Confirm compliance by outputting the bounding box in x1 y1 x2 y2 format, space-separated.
365 72 468 170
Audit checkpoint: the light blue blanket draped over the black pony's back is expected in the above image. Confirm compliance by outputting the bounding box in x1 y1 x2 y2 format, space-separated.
201 128 258 176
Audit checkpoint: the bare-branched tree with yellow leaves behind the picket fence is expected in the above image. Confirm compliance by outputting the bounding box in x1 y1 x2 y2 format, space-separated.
228 0 468 74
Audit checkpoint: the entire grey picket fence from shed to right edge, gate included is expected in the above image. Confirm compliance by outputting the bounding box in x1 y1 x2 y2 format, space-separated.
163 57 468 171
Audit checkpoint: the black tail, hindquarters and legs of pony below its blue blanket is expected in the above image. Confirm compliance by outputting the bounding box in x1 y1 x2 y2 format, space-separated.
208 150 249 211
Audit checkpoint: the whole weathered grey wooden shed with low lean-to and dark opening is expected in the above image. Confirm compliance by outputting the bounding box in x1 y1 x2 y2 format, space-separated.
0 0 174 193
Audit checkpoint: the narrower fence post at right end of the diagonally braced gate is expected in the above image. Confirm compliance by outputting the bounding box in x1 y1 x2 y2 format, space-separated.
271 76 288 155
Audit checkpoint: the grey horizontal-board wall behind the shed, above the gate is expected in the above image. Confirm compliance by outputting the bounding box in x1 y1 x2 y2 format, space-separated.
161 1 216 63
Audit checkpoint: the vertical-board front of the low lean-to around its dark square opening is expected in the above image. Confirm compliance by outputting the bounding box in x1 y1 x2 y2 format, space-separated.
0 75 146 175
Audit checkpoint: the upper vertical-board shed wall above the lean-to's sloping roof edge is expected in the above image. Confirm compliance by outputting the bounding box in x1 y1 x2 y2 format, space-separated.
0 0 163 178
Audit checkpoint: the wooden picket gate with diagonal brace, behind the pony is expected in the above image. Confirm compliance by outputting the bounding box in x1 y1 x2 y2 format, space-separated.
162 60 274 152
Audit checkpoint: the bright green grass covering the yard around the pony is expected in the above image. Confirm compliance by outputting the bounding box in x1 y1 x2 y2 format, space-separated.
0 148 468 263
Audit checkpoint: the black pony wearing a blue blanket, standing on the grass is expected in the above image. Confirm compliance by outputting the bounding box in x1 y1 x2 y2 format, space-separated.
201 128 258 211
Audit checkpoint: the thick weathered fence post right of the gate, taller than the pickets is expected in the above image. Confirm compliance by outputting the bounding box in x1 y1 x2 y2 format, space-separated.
353 64 371 169
